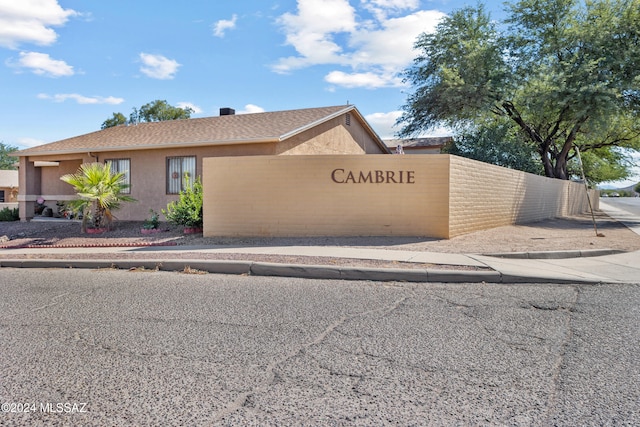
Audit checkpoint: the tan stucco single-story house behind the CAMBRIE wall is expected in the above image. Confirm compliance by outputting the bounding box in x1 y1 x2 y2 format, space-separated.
15 105 390 221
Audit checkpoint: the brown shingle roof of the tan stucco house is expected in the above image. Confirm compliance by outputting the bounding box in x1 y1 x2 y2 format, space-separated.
16 105 370 156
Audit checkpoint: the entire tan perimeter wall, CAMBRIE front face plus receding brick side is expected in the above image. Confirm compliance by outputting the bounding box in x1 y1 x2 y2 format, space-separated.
202 155 588 238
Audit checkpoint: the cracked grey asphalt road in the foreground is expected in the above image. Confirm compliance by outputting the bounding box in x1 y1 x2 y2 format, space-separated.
0 268 640 426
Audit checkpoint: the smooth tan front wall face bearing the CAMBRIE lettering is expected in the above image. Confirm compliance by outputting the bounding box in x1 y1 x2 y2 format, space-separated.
203 155 449 238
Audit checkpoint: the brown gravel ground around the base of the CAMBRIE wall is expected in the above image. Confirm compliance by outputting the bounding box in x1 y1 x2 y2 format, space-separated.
0 212 640 268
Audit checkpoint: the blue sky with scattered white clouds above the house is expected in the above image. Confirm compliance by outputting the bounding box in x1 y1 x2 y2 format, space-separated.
0 0 638 187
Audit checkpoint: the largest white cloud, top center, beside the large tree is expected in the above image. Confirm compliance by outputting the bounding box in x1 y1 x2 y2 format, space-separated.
272 0 445 88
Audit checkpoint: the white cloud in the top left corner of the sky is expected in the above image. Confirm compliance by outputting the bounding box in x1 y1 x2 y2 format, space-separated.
0 0 78 49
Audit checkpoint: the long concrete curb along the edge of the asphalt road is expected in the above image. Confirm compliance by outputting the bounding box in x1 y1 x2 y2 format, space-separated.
0 259 600 284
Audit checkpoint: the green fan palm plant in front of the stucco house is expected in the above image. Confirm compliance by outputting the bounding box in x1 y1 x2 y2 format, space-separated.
60 162 136 233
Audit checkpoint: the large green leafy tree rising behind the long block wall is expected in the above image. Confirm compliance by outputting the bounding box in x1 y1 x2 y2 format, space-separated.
399 0 640 179
